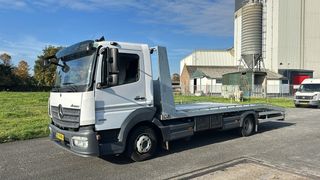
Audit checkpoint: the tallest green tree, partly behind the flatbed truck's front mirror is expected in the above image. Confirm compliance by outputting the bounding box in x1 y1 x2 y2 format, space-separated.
33 46 62 86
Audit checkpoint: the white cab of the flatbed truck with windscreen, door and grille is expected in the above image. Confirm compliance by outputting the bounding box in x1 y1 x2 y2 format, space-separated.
49 41 155 158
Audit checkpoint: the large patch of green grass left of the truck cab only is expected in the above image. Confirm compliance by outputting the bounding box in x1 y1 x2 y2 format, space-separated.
0 92 49 143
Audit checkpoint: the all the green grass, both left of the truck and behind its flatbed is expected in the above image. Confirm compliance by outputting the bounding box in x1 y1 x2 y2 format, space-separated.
0 92 294 143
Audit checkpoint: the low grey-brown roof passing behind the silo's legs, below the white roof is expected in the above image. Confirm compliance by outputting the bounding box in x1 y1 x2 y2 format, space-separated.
185 66 283 79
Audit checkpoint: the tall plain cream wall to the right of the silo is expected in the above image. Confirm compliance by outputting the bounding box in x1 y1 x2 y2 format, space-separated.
265 0 320 78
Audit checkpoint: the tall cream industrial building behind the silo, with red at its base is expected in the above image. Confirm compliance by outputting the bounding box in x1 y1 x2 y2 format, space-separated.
234 0 320 85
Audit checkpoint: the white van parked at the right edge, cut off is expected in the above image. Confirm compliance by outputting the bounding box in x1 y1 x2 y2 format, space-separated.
294 78 320 108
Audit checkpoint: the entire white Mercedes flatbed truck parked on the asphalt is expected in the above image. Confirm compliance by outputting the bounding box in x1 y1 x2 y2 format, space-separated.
43 39 285 161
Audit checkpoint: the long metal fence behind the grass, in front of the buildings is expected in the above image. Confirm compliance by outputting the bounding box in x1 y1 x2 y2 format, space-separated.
180 84 296 98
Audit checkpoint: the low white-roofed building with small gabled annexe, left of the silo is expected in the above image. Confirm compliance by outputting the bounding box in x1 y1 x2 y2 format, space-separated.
180 49 238 94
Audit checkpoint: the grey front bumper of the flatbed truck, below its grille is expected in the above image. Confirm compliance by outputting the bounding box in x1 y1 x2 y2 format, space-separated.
49 124 99 156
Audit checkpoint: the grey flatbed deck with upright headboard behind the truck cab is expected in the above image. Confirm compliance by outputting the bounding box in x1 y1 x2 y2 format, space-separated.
154 47 285 120
